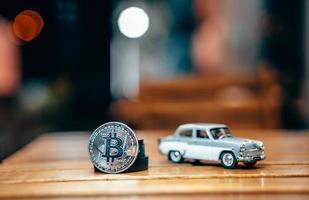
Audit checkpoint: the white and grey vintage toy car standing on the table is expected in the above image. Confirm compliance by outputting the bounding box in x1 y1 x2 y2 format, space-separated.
159 123 265 168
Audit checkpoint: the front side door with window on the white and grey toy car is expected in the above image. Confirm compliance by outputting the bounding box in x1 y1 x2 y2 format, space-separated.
190 129 217 160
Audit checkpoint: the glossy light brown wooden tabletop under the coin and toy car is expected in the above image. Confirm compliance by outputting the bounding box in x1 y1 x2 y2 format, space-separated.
0 130 309 200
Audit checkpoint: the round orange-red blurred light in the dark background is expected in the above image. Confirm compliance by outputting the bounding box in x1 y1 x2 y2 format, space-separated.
12 10 44 42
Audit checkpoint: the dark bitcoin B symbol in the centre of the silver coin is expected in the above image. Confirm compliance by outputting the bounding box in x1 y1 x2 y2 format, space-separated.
103 133 123 162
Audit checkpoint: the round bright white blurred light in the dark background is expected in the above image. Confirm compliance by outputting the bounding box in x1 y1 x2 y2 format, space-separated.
118 7 149 38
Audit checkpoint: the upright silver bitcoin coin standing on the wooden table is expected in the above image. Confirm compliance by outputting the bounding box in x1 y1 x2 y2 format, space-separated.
88 122 138 173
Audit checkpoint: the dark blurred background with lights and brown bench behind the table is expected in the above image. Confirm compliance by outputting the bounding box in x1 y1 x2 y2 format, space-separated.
0 0 309 160
